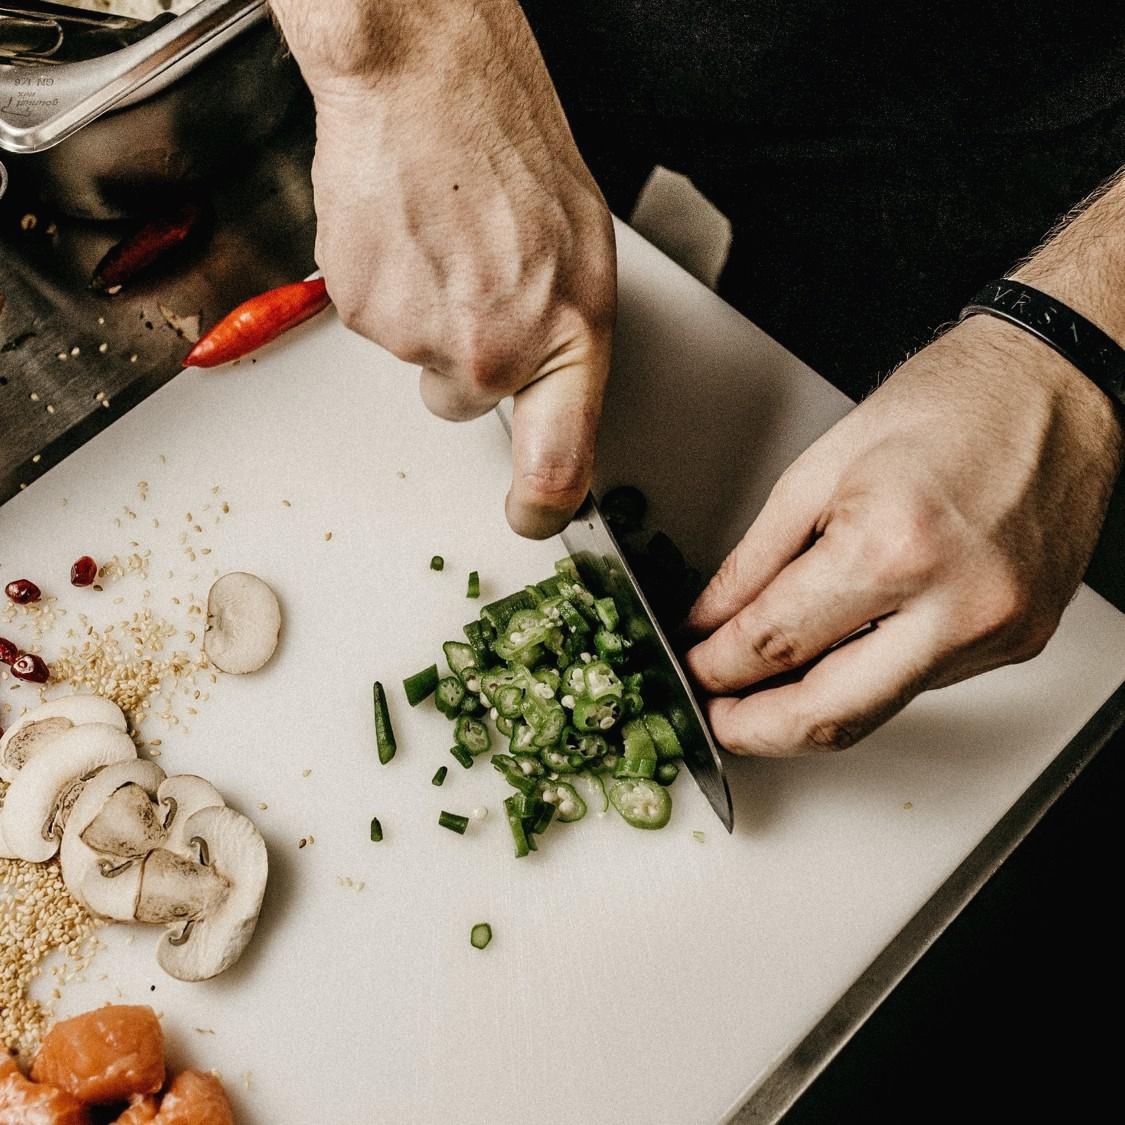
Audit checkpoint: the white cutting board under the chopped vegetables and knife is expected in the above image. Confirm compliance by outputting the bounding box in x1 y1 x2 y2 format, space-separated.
0 221 1125 1125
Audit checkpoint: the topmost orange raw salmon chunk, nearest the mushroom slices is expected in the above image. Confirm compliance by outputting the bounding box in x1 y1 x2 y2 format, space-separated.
32 1004 164 1106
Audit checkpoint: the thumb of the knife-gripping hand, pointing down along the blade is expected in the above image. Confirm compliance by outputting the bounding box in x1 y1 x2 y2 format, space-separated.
505 329 611 539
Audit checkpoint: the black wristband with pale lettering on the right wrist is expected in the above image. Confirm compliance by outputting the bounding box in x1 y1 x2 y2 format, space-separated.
960 278 1125 406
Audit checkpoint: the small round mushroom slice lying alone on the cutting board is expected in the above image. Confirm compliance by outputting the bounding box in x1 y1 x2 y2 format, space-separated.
204 570 281 674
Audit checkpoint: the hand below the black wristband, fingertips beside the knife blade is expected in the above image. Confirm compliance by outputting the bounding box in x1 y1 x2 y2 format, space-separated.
687 316 1123 756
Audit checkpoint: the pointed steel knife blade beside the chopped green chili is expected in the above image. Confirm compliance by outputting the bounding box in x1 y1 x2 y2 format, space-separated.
496 399 735 833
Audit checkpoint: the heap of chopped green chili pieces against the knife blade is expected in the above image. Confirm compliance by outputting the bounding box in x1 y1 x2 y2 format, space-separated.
427 542 697 857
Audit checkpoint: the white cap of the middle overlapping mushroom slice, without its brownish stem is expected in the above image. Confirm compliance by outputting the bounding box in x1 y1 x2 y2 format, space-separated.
60 758 164 921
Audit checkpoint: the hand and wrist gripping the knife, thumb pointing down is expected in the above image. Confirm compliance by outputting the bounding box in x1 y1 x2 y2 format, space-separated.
267 0 617 538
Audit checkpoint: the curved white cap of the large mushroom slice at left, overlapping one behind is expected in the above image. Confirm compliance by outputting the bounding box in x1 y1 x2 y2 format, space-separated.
0 722 137 863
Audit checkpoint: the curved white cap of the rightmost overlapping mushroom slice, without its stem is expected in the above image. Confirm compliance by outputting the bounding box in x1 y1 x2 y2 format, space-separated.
156 807 269 981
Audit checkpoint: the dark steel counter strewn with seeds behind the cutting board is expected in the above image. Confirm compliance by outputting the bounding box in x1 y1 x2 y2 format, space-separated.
0 90 315 503
